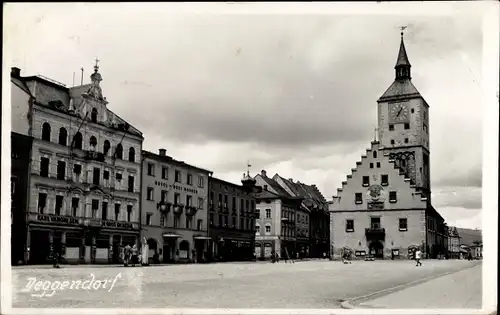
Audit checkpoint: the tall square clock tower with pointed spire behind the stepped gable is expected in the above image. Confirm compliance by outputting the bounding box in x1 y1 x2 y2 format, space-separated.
377 32 431 201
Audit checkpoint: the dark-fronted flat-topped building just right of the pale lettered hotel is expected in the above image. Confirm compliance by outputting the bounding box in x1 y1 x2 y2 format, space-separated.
208 174 255 261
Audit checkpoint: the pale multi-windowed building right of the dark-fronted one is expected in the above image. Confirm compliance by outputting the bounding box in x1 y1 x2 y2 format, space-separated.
254 170 302 259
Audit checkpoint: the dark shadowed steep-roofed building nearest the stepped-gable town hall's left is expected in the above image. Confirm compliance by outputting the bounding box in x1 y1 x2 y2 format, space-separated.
273 174 330 258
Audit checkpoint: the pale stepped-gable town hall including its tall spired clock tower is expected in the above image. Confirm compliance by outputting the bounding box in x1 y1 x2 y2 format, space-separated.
329 33 447 258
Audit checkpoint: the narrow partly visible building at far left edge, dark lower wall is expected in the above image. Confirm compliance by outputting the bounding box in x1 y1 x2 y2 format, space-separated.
10 68 34 265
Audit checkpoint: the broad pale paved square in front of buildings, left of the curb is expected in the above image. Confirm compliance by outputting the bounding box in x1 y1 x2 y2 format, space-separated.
12 260 480 308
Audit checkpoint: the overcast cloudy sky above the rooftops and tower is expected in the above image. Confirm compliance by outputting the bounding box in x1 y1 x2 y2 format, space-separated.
4 3 488 228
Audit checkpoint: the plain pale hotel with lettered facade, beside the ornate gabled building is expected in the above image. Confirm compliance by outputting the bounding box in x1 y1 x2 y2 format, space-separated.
141 149 212 262
